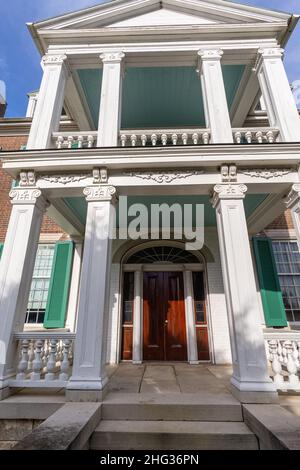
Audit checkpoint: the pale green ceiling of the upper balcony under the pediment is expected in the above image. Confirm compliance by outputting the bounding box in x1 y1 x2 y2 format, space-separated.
77 65 245 129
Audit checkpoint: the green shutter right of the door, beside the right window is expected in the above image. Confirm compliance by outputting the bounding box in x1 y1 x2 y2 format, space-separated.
253 237 287 327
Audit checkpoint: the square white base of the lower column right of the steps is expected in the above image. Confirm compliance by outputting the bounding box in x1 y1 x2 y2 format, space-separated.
230 377 279 404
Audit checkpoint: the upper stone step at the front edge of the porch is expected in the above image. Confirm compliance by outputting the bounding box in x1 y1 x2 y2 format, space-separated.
102 393 243 422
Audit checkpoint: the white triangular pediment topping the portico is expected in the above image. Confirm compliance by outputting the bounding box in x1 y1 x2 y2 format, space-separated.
34 0 290 30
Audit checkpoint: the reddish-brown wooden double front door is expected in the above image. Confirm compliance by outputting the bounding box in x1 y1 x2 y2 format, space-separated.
143 272 187 361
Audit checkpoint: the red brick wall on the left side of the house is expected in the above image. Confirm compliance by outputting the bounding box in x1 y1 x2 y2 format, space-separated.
0 135 66 243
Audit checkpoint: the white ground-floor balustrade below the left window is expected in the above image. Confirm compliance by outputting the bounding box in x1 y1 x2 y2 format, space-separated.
9 332 76 388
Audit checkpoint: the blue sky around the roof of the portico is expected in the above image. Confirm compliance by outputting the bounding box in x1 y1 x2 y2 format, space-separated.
0 0 300 117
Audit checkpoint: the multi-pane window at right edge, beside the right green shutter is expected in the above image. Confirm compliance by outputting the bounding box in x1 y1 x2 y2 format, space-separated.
272 241 300 322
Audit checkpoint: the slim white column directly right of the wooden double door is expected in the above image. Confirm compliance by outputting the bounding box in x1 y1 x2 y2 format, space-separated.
183 271 199 364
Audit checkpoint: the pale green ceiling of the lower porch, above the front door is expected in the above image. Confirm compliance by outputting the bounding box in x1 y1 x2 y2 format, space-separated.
64 194 267 227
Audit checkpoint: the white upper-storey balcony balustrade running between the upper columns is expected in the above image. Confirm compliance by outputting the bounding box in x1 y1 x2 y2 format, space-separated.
53 127 280 149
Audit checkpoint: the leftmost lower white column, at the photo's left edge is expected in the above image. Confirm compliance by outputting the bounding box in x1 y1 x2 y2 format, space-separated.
0 188 47 398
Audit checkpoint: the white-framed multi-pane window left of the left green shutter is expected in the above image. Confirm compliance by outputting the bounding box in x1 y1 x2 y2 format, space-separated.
25 245 54 323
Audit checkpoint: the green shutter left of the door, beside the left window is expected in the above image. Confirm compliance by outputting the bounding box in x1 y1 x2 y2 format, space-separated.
44 241 73 328
